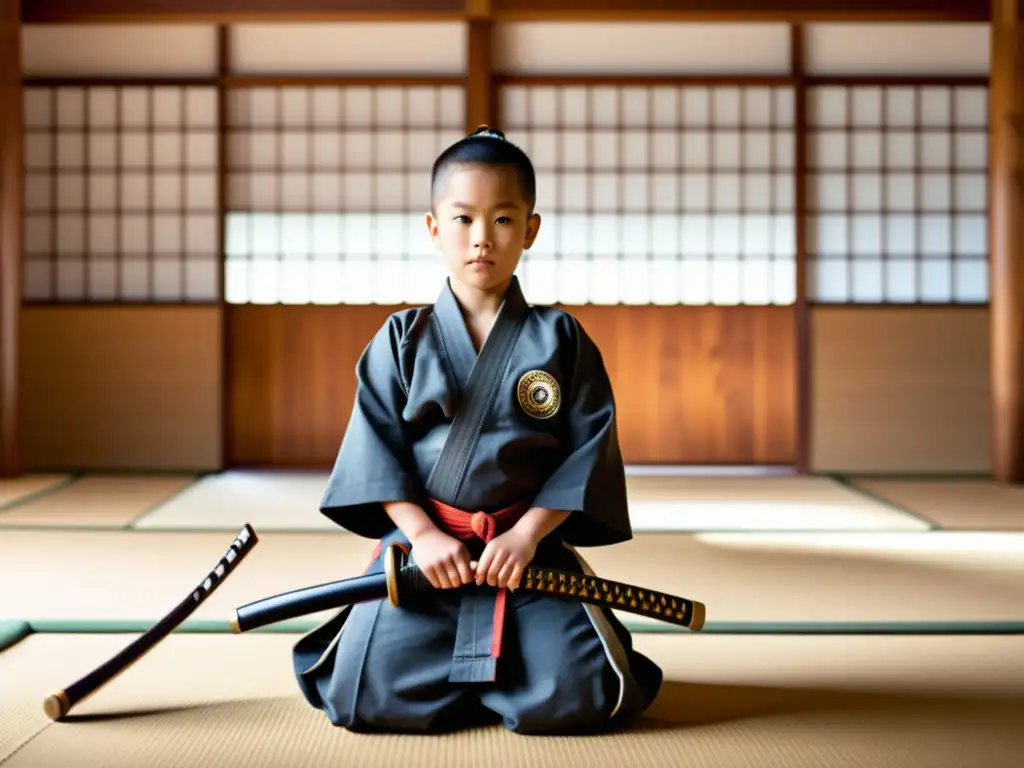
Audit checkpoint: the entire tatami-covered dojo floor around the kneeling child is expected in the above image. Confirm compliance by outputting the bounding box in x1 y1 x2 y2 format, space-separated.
0 472 1024 768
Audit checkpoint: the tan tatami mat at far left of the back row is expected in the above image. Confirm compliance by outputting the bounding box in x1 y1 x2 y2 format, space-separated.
0 475 195 527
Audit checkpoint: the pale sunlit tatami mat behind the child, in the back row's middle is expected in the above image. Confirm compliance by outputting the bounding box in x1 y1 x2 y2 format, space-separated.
130 471 928 532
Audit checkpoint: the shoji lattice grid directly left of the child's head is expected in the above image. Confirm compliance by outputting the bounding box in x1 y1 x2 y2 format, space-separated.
224 85 465 304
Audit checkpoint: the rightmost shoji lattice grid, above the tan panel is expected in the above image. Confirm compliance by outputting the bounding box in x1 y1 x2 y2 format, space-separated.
807 85 988 303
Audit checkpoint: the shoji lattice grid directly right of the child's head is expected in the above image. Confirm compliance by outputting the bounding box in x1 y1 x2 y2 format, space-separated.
502 83 796 304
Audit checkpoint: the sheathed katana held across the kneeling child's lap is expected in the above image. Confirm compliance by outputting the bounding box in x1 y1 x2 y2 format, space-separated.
228 544 706 634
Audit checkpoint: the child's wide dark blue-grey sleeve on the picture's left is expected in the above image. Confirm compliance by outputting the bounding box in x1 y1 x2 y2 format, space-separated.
319 315 422 539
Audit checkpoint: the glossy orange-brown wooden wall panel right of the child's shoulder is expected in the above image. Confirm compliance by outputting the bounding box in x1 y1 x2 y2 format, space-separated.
570 306 796 464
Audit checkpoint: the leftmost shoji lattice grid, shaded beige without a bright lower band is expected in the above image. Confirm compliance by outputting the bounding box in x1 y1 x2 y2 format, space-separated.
25 86 221 302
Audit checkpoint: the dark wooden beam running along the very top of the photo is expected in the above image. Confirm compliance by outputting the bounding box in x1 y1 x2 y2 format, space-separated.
22 0 989 24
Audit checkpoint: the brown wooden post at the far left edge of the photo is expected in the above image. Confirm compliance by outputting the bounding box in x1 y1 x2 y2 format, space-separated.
0 0 25 477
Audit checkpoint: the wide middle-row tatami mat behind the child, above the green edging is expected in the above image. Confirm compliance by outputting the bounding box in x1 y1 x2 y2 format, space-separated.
0 528 1024 623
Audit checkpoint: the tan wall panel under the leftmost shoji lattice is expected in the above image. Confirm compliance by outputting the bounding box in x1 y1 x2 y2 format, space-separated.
20 306 223 471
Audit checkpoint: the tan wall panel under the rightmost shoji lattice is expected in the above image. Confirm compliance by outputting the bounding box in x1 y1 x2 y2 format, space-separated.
811 307 991 473
